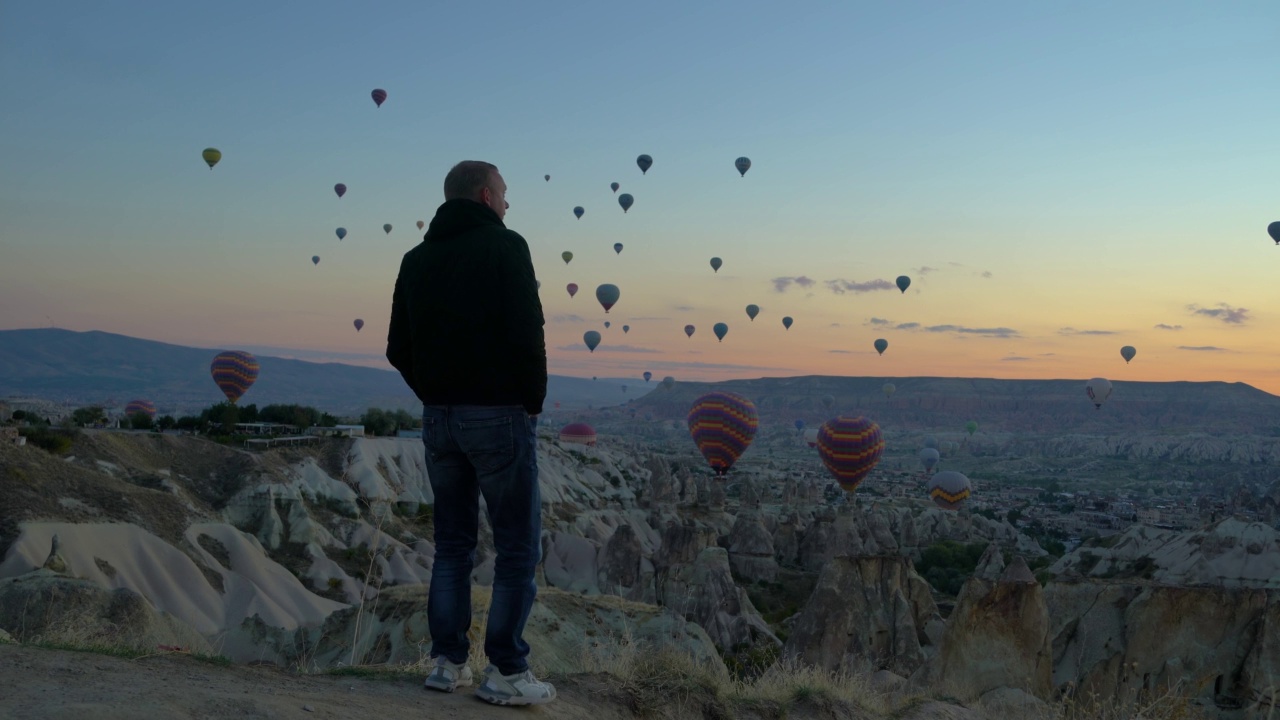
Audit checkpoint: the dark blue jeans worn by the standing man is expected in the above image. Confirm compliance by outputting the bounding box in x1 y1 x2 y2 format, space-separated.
422 405 543 675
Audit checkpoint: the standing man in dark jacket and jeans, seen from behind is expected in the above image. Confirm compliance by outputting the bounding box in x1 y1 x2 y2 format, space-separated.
387 160 556 705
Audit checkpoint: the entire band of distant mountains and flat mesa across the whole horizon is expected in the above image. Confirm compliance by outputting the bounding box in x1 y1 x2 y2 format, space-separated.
0 329 1280 436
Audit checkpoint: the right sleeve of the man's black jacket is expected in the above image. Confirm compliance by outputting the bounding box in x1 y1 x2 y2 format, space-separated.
507 232 547 415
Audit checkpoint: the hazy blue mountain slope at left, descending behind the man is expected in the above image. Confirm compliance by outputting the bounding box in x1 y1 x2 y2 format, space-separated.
0 328 657 415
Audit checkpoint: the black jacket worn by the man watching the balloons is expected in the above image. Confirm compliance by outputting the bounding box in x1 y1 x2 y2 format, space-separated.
387 200 547 415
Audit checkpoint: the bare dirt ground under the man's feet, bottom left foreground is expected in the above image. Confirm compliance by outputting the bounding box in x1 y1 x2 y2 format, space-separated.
0 644 645 720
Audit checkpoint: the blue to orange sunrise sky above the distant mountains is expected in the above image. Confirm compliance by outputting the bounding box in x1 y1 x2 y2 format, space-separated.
0 0 1280 393
